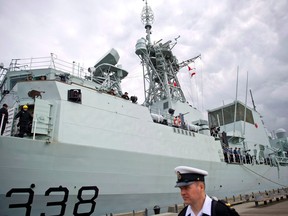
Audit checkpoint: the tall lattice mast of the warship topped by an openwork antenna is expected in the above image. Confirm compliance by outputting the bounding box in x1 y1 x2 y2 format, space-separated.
136 0 186 107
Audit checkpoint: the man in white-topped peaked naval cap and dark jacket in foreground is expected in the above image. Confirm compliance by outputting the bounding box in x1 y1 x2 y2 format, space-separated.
175 166 238 216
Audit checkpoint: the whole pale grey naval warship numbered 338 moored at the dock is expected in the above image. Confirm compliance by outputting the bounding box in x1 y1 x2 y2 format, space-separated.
0 3 288 215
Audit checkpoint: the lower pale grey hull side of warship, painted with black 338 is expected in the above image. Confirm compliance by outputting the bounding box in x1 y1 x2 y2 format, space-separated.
0 137 288 215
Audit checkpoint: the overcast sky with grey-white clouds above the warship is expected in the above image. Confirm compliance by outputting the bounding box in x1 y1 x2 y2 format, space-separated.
0 0 288 135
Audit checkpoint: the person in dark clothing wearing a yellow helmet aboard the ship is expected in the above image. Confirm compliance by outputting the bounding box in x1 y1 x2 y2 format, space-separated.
15 105 32 137
